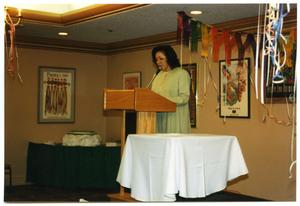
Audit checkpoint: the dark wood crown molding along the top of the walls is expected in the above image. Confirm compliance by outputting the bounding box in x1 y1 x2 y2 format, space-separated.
16 10 297 55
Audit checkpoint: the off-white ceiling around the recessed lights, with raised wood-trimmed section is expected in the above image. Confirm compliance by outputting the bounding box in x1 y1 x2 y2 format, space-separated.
5 4 296 53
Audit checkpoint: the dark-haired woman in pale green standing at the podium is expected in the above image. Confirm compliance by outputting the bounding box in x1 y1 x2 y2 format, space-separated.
151 45 191 133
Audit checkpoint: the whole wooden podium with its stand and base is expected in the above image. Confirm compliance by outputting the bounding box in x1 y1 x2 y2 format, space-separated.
104 88 176 201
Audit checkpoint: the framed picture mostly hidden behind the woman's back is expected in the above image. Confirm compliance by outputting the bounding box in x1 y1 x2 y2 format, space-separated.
182 63 197 128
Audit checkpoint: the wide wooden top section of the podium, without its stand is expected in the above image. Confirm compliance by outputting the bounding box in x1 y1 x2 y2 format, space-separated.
104 88 176 112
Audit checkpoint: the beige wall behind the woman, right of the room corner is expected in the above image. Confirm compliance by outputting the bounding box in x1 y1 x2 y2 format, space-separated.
106 46 296 201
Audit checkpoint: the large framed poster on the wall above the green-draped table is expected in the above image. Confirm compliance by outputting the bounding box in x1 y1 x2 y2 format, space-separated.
38 66 75 123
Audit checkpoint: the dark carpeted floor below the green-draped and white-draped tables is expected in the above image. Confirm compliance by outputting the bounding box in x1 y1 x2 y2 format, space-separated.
4 185 266 203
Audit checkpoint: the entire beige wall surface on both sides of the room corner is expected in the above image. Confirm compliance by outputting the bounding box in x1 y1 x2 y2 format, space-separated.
5 46 296 201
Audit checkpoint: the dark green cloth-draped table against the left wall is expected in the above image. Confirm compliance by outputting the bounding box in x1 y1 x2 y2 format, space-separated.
26 142 121 190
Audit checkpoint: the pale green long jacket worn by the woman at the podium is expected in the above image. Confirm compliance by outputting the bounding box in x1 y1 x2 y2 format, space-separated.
151 67 191 133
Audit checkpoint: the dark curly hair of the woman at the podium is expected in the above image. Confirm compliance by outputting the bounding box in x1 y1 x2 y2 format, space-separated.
152 45 180 69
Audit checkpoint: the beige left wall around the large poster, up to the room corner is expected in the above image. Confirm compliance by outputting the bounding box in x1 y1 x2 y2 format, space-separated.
5 49 107 184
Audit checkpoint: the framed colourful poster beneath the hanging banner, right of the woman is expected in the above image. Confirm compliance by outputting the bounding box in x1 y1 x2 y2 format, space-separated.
219 58 250 118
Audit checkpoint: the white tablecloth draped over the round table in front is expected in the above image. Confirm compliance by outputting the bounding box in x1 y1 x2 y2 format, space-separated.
117 134 248 201
